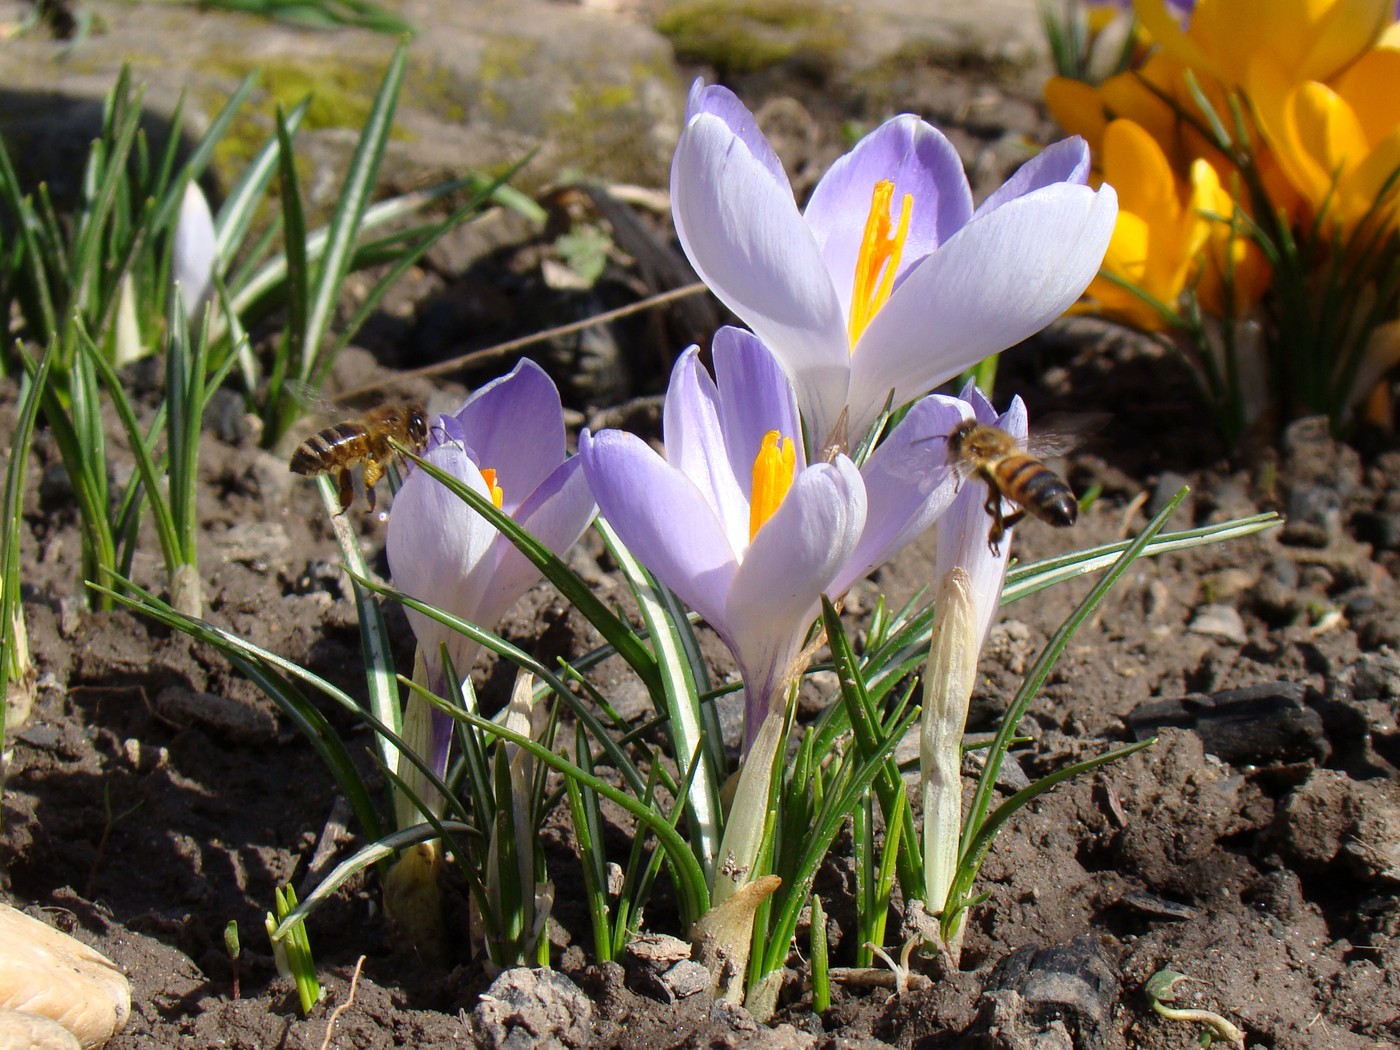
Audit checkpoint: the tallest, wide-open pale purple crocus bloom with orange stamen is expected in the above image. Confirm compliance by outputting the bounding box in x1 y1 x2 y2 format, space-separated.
671 81 1117 442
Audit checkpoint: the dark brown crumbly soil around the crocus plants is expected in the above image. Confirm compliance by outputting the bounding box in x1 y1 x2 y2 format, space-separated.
8 45 1400 1050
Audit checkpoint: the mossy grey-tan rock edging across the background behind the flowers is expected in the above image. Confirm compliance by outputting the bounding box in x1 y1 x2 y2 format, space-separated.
0 0 1040 211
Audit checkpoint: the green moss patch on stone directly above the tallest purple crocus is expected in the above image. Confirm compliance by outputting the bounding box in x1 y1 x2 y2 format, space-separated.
657 0 843 78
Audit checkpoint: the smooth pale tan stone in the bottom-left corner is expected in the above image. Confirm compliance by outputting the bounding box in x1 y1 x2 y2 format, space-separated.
0 904 132 1050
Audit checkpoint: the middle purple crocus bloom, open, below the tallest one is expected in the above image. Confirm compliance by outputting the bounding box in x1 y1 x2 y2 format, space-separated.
578 328 966 745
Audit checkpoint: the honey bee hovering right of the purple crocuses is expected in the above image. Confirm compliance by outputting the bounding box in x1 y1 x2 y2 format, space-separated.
946 417 1102 554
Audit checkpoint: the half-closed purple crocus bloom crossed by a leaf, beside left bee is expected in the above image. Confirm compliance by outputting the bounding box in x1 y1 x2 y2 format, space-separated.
385 360 596 722
